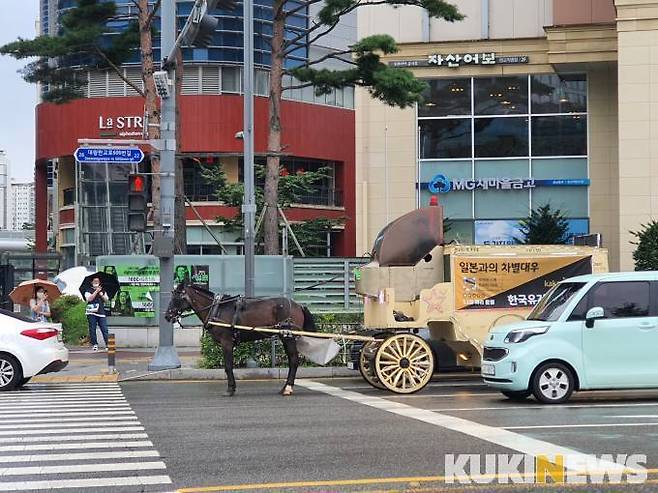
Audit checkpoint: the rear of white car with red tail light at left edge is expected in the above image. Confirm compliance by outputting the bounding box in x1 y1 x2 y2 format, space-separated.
0 309 69 391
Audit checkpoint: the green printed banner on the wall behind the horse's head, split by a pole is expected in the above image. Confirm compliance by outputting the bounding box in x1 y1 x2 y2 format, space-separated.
104 264 210 318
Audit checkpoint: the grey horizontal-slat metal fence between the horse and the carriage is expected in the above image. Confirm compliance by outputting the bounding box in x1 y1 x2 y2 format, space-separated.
293 257 369 313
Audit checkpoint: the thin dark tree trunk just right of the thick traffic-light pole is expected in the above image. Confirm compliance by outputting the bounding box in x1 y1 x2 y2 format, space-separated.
174 48 187 255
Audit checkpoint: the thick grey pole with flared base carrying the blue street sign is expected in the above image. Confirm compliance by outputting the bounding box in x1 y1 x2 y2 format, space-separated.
149 0 181 371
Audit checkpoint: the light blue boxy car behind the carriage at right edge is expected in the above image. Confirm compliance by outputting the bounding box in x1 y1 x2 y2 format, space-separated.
481 271 658 404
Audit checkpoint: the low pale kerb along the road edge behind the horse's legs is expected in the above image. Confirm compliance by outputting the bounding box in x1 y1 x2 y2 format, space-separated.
119 367 359 382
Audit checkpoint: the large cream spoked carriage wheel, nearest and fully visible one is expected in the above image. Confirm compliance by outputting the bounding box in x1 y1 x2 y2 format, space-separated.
374 334 434 394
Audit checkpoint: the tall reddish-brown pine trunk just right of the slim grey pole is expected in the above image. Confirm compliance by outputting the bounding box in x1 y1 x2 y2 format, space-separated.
263 0 285 255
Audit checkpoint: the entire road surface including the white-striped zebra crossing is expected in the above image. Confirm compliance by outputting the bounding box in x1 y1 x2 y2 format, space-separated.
0 376 658 493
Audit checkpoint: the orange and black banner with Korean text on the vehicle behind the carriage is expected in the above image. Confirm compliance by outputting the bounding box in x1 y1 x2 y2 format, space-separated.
452 255 592 310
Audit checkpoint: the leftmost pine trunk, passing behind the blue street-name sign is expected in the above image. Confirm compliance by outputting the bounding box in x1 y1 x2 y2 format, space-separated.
138 0 162 230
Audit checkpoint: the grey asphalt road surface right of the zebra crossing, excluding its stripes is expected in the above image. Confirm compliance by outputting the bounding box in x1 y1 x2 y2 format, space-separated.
122 378 658 493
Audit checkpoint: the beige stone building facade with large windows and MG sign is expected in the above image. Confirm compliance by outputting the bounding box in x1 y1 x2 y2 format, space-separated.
356 0 658 269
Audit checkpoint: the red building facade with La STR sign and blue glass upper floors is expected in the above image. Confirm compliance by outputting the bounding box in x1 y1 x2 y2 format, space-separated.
35 0 356 265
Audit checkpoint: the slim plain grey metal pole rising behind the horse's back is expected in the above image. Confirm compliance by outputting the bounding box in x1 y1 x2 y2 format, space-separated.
242 0 256 298
